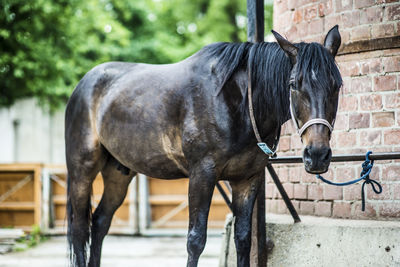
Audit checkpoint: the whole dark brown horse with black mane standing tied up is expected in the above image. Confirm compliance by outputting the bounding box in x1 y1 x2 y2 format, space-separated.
65 26 342 267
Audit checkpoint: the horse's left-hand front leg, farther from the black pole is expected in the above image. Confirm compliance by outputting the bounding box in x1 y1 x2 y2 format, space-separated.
187 159 216 267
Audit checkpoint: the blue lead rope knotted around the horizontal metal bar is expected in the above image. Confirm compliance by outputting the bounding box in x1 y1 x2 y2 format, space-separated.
317 151 382 211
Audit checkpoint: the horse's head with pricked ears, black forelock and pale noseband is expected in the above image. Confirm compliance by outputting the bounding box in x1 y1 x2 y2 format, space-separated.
273 26 342 173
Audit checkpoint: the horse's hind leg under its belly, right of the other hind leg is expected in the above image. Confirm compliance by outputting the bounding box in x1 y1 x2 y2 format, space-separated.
89 156 136 267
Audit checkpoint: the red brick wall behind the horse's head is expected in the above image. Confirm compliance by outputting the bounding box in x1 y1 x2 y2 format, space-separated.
266 0 400 219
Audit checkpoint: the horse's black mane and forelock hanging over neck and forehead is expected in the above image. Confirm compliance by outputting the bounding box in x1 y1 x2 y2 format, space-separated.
201 42 342 124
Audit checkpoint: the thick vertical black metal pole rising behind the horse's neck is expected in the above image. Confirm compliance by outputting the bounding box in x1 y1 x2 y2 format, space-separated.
247 0 267 267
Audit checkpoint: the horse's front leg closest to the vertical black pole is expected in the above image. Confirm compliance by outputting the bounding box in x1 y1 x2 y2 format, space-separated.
230 175 263 267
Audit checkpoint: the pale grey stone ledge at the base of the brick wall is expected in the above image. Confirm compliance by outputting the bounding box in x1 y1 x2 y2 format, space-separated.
220 214 400 267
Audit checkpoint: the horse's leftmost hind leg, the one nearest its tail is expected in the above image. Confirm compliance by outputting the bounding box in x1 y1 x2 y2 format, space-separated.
67 144 106 267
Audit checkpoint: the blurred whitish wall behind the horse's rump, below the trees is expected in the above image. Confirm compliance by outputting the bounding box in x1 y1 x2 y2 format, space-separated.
0 99 65 164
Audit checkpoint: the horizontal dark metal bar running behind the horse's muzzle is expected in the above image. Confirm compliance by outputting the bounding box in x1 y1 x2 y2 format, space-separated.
269 152 400 164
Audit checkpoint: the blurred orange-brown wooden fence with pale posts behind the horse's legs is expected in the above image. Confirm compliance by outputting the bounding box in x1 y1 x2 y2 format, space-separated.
0 164 229 234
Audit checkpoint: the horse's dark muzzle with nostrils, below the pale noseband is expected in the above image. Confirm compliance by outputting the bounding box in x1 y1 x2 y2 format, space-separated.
303 146 332 174
